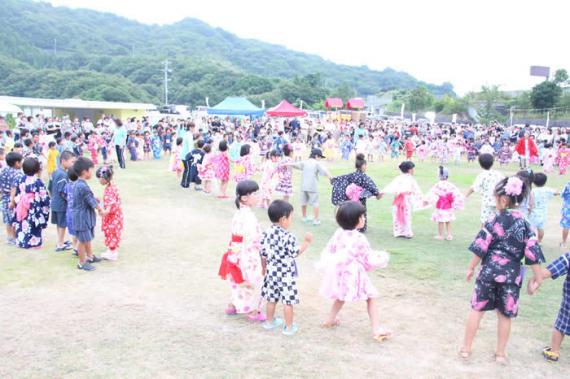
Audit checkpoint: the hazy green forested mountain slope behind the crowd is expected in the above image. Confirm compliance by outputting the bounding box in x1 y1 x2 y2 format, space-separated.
0 0 453 105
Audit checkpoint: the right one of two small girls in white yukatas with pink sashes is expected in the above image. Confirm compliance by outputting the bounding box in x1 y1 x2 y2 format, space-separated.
426 166 464 241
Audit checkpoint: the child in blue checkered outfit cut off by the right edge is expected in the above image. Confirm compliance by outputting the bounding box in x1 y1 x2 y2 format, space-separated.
529 252 570 362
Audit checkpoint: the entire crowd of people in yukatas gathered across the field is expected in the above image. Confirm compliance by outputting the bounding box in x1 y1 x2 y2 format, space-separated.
0 115 570 362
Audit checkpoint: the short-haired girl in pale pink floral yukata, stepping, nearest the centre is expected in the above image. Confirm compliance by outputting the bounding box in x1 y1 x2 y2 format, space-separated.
318 201 392 341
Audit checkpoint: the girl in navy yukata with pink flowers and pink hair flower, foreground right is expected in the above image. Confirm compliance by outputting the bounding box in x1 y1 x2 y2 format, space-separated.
460 176 544 363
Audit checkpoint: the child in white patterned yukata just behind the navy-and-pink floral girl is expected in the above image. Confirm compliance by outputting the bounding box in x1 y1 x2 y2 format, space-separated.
465 154 504 225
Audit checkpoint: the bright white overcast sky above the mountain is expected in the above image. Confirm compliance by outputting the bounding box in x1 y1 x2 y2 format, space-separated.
49 0 570 94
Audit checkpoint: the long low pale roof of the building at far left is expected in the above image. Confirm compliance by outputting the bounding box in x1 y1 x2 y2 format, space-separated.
0 96 156 110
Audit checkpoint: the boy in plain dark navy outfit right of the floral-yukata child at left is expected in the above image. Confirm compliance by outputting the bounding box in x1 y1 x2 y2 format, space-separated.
48 150 75 252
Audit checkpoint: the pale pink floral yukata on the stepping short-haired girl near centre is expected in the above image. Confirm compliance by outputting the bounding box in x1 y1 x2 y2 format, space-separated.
318 229 389 301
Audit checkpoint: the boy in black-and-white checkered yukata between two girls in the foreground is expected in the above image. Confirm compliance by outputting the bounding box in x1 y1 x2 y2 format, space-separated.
261 200 313 336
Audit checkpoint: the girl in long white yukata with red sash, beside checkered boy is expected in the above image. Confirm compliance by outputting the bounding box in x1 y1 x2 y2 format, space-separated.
219 180 265 321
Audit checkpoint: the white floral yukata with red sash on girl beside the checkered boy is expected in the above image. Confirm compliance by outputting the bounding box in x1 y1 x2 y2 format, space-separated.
219 205 263 313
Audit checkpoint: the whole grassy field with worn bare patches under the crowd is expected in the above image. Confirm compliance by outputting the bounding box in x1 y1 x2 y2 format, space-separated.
0 156 570 377
